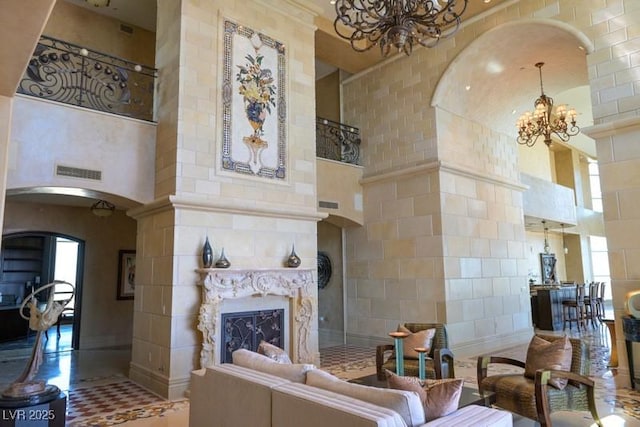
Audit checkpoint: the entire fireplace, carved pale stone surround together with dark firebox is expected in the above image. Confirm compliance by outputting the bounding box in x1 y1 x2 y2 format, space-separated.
198 268 315 367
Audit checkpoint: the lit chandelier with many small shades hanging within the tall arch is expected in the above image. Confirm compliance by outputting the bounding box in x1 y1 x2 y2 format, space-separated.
516 62 580 147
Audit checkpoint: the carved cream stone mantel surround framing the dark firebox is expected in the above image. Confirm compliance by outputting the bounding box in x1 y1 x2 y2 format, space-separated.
197 268 314 368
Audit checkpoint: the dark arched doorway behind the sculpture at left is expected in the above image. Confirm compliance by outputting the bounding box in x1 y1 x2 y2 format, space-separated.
0 232 84 352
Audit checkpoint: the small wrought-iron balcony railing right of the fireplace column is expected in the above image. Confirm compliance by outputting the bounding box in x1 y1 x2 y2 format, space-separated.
316 117 360 165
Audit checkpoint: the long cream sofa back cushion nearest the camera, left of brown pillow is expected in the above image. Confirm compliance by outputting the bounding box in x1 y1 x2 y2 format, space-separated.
306 369 425 426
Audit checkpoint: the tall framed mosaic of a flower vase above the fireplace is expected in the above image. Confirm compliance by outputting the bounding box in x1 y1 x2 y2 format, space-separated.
221 20 286 179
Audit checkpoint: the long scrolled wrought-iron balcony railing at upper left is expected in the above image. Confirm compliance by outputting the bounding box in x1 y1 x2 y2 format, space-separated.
18 36 157 121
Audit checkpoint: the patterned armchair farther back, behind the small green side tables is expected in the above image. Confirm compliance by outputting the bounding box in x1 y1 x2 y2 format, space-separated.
376 323 455 381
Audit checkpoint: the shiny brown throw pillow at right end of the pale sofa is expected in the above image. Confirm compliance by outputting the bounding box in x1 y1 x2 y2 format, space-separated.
385 370 464 421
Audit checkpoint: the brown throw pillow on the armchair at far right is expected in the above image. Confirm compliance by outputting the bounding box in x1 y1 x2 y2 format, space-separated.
524 335 573 390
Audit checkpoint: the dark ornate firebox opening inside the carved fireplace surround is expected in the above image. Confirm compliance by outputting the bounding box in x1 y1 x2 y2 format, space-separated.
220 309 285 363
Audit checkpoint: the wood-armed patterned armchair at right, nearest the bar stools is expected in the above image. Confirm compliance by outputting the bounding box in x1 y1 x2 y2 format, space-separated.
477 335 602 427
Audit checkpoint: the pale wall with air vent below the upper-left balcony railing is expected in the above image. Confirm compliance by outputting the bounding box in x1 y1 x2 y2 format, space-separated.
7 96 156 208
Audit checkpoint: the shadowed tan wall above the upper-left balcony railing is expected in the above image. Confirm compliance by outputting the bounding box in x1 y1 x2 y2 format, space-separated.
43 0 155 67
